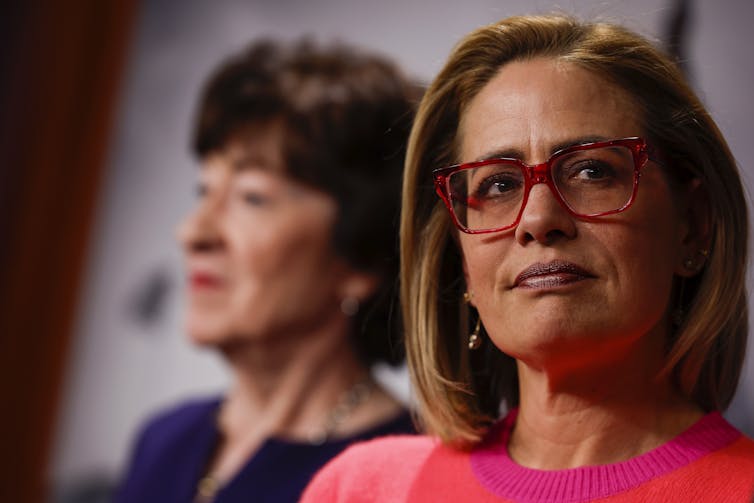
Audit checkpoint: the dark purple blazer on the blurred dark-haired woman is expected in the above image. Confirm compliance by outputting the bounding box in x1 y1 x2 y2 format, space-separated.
115 398 415 503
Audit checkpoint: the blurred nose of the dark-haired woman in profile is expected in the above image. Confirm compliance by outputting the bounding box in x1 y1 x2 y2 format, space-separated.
176 195 223 254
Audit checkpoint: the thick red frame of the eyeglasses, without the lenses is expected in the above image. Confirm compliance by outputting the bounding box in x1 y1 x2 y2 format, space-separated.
432 137 651 234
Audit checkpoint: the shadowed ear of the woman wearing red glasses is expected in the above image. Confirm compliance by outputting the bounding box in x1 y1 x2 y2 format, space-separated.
675 178 712 278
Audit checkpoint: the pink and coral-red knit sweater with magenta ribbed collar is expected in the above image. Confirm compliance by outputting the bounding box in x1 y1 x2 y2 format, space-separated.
301 412 754 503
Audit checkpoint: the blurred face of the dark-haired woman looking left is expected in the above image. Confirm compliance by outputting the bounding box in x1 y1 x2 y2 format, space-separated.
179 127 354 345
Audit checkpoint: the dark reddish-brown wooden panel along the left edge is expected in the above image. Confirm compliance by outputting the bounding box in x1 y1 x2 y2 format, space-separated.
0 0 138 502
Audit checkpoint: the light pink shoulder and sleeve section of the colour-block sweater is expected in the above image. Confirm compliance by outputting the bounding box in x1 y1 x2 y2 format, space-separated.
301 435 436 503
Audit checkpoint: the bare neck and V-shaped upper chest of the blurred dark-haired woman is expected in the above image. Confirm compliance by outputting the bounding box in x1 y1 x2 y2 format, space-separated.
200 316 400 483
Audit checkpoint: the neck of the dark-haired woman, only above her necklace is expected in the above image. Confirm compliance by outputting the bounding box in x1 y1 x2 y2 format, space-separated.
219 320 368 440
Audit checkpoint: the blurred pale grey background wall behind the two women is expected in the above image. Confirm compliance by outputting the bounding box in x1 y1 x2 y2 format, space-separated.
48 0 754 497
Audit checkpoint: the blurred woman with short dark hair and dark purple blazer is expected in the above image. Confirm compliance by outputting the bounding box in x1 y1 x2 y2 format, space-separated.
119 41 415 503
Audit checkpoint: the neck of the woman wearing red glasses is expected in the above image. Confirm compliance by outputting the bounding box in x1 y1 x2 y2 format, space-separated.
508 330 702 470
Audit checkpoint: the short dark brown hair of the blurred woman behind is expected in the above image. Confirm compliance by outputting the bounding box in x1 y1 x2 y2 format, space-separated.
193 39 420 364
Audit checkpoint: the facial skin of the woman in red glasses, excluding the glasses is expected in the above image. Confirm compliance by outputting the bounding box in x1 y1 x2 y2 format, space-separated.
460 59 687 372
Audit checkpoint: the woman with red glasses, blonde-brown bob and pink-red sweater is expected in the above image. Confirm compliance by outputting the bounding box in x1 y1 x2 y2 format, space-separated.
304 16 754 502
